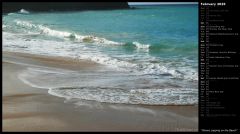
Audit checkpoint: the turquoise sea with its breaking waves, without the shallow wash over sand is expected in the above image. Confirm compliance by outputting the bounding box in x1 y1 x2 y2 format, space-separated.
2 5 198 104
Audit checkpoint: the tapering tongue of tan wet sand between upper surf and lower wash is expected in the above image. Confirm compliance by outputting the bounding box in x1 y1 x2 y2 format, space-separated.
2 51 101 70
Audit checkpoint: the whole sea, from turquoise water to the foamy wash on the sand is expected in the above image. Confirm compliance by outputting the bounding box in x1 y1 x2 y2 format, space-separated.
2 4 198 105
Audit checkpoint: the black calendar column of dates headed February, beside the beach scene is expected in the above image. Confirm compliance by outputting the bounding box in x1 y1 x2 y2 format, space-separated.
199 0 240 128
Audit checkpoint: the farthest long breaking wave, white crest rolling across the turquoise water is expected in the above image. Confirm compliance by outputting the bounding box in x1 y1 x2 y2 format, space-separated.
6 19 197 52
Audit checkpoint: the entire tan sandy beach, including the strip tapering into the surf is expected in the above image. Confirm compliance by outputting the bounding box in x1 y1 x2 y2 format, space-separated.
2 52 198 131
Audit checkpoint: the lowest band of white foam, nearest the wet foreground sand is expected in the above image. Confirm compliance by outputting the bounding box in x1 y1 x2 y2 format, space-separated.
48 87 198 105
